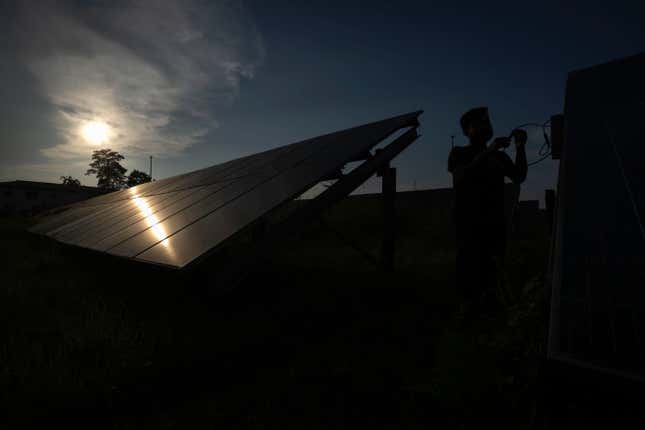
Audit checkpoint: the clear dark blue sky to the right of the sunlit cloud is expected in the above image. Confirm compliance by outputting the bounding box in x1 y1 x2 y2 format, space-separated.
181 1 645 203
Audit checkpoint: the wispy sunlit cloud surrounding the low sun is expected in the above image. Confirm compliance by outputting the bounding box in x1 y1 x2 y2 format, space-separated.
14 0 265 161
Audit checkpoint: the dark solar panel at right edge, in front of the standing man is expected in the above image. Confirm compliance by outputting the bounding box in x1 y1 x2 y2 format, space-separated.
549 55 645 378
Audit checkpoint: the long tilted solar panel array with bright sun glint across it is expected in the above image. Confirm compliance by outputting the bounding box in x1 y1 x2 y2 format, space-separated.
31 112 421 268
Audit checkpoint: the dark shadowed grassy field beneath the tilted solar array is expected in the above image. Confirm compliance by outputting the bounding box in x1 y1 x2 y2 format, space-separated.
0 194 548 429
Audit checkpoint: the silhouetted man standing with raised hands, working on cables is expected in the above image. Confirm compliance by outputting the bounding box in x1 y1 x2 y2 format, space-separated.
448 107 527 312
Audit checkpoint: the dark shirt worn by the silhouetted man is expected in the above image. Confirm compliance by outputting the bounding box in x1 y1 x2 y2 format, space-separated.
448 146 516 253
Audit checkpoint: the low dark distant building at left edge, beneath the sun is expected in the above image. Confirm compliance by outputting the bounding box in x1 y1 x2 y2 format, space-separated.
0 181 101 215
